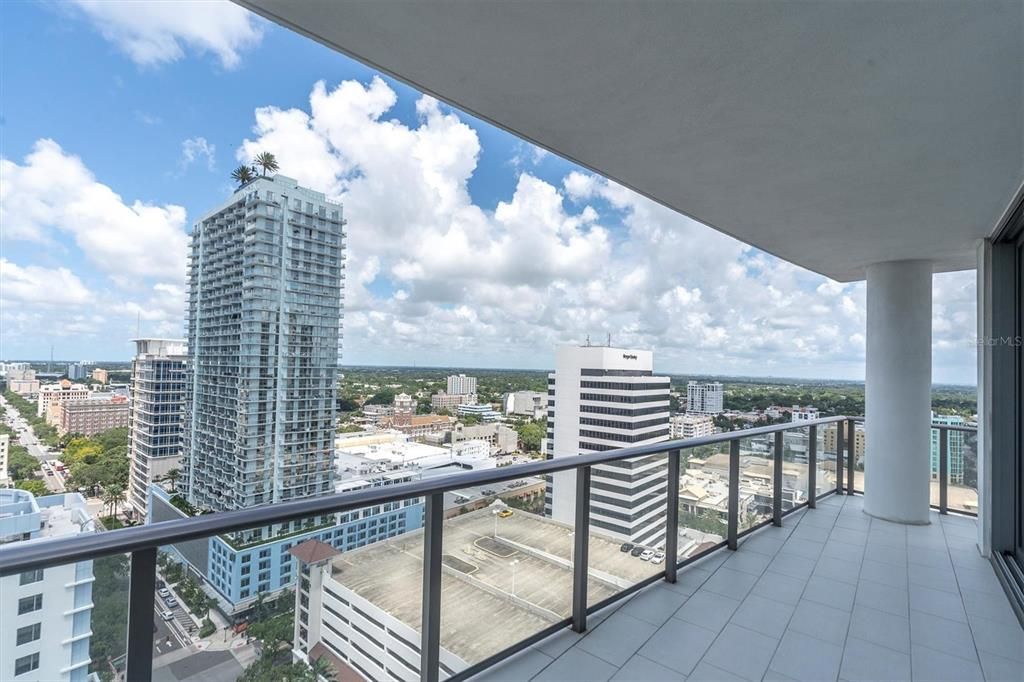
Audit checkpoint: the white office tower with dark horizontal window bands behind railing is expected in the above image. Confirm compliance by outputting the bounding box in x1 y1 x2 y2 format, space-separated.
545 346 670 546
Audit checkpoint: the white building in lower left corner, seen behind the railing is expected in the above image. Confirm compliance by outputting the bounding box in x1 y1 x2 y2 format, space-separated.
0 488 96 682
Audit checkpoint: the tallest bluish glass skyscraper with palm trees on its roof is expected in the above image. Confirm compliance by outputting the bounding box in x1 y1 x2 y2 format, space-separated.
183 175 344 511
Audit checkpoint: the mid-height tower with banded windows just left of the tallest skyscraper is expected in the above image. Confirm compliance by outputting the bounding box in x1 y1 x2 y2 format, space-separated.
128 339 186 519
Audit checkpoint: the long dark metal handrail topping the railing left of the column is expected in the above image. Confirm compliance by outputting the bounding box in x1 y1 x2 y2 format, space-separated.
0 417 848 577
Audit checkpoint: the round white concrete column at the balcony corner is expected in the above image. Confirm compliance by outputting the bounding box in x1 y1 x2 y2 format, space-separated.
864 260 932 523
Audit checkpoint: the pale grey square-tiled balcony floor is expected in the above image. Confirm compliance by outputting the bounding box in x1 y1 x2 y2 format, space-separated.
474 496 1024 682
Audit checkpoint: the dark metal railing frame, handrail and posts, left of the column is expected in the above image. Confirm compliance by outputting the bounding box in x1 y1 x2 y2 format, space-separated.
0 416 854 682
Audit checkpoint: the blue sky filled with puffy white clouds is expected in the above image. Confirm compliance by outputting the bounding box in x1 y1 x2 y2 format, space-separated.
0 0 975 383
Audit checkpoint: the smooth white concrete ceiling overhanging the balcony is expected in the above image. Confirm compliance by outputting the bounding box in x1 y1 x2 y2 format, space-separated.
241 0 1024 281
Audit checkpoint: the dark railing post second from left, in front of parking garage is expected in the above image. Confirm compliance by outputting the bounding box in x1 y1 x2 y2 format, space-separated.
420 493 444 682
